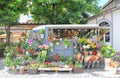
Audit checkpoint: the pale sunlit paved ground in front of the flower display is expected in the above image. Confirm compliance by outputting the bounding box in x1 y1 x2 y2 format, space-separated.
0 58 120 78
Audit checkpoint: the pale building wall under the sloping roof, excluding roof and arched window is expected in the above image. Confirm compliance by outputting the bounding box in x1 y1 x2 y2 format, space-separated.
88 9 120 52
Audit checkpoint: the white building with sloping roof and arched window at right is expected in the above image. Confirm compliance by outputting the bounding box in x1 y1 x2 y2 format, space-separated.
88 0 120 52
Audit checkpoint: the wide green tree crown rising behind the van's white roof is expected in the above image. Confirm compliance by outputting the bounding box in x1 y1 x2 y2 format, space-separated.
30 0 100 24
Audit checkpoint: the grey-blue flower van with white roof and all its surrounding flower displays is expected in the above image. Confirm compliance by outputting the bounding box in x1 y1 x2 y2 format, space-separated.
5 24 117 74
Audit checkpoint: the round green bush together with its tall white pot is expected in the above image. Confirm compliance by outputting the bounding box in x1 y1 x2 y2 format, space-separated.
101 45 115 70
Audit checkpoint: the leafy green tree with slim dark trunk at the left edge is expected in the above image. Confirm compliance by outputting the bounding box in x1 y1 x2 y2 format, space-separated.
0 0 28 43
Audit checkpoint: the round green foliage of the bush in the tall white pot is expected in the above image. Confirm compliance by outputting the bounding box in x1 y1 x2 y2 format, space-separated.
101 45 115 58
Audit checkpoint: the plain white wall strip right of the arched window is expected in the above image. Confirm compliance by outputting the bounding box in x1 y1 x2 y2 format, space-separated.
113 9 120 52
